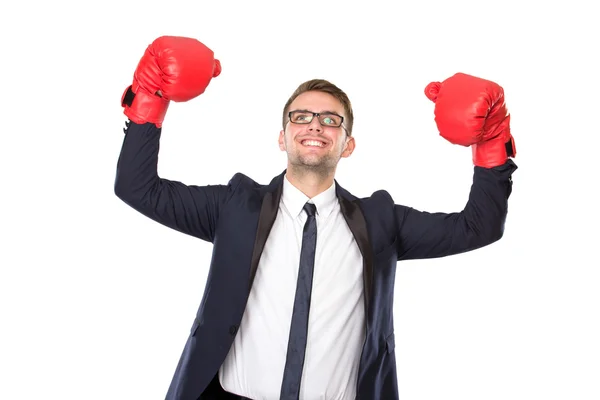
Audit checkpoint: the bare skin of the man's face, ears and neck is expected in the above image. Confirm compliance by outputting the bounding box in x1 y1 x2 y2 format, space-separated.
279 91 355 198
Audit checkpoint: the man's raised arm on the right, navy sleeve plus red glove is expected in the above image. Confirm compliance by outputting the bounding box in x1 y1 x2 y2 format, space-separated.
394 73 517 260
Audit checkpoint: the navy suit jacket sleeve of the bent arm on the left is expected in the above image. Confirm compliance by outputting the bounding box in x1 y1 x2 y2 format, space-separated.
114 122 232 242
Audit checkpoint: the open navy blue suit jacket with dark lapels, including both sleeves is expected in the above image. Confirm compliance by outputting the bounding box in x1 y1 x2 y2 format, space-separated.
115 122 517 400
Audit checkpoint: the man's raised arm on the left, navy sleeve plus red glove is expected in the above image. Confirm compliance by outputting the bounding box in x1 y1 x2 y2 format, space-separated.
114 36 225 242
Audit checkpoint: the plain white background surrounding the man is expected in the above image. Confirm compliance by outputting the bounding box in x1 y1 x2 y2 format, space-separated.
0 0 600 400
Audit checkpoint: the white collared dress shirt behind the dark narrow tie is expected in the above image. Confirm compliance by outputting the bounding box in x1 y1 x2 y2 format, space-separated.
219 176 365 400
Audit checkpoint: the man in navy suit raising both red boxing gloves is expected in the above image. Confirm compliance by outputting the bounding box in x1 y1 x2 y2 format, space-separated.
115 37 516 400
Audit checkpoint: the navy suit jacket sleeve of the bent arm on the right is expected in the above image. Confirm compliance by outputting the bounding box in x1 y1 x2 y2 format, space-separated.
394 159 517 260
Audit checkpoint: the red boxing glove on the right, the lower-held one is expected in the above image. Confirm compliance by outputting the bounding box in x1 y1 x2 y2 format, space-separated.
425 73 517 168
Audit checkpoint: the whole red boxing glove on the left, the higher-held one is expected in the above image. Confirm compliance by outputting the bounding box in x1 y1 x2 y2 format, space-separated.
121 36 221 128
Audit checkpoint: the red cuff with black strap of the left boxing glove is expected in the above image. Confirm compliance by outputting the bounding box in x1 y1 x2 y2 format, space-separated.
121 86 169 128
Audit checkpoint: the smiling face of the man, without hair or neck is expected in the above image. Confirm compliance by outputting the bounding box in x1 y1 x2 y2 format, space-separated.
279 91 354 172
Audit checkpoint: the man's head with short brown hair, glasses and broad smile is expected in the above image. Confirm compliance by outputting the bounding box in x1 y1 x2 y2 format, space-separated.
279 79 355 173
